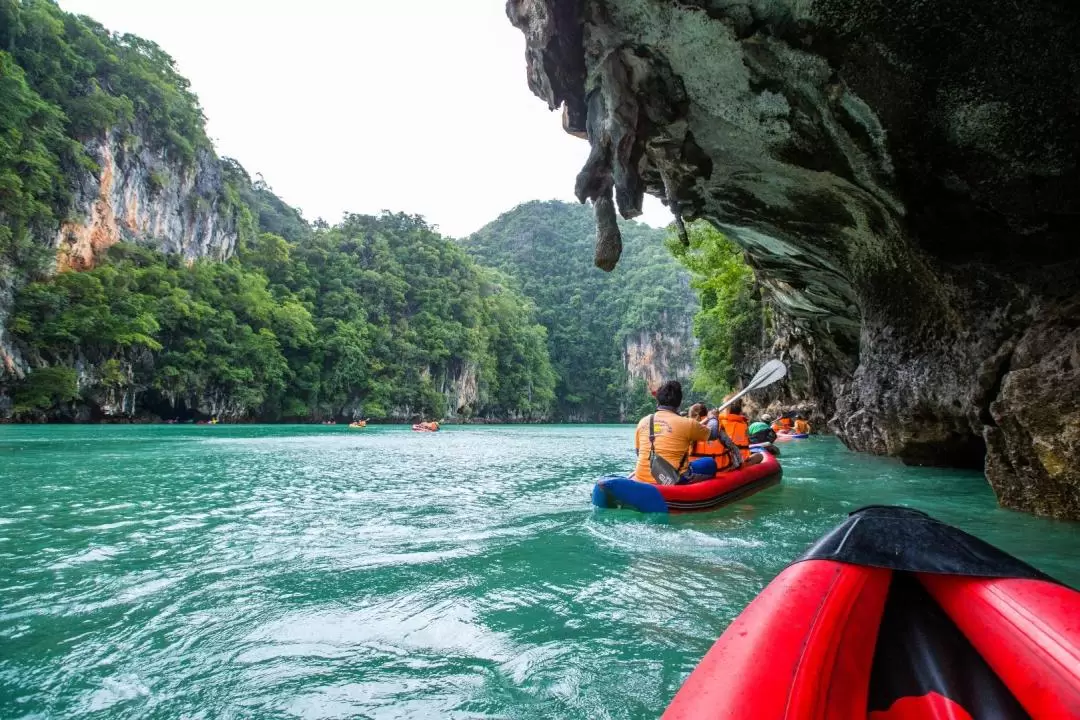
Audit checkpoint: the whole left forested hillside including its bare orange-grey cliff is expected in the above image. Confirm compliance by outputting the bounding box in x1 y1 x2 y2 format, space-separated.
0 0 555 420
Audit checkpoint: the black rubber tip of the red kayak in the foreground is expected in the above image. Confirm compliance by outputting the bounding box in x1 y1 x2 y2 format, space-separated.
796 505 1063 584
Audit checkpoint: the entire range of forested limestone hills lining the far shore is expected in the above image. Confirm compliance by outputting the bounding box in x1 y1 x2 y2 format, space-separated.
0 0 760 422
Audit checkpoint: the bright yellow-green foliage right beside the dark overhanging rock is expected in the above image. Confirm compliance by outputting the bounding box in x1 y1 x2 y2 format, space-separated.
667 221 764 402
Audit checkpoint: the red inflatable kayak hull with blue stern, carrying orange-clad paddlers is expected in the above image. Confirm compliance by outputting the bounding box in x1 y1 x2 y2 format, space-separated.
593 454 783 513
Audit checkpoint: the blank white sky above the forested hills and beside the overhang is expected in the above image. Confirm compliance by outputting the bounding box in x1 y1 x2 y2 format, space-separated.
60 0 671 236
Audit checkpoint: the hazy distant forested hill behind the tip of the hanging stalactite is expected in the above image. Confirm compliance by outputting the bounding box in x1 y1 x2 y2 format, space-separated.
462 202 697 421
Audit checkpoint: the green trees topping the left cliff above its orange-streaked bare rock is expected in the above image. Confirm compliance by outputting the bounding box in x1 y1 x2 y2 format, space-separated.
0 0 211 274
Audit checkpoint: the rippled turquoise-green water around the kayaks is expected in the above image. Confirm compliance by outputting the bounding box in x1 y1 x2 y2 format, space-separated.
0 426 1080 719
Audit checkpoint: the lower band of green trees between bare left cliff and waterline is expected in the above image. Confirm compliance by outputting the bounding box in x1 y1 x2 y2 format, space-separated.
9 197 554 420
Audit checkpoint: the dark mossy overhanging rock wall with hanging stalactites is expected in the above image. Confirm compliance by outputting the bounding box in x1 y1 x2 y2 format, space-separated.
508 0 1080 518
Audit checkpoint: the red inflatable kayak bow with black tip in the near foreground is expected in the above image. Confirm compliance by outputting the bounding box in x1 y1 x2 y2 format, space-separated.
664 507 1080 720
